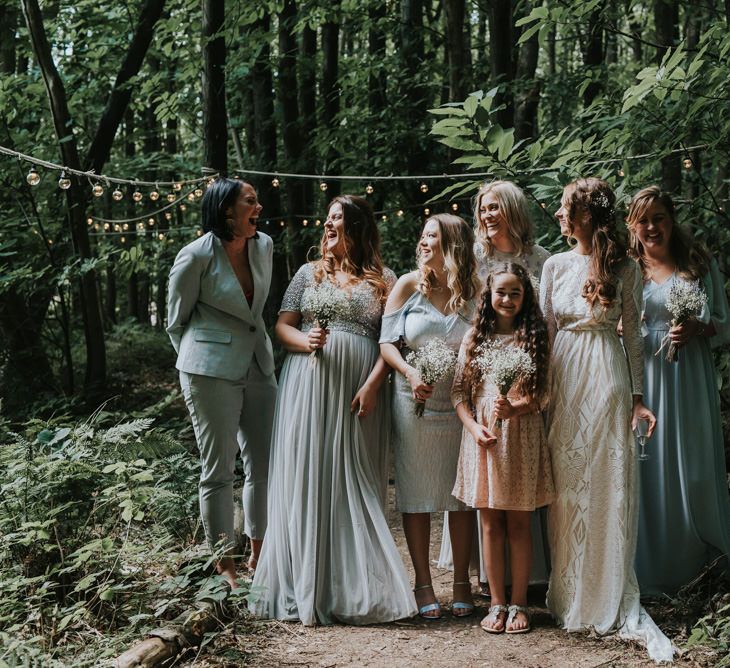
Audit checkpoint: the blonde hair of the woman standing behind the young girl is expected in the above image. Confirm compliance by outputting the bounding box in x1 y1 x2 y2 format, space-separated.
474 180 535 256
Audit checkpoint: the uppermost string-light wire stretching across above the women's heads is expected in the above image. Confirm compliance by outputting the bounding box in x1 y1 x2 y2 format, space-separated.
0 144 709 187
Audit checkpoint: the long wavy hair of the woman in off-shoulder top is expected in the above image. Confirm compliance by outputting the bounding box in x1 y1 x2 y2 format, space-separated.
416 213 479 313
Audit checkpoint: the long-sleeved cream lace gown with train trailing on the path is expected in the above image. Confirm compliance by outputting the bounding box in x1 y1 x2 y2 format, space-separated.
540 251 673 661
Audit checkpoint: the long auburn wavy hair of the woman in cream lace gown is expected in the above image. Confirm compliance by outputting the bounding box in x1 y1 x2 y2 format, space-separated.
562 176 627 308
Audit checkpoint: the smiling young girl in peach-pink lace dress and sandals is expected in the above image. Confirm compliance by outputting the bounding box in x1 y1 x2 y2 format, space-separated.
451 262 554 633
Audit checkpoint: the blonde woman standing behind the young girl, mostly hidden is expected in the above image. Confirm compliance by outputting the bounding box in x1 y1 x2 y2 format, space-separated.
438 180 550 595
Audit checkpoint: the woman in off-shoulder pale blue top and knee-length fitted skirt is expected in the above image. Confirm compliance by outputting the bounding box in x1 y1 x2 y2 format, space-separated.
380 214 478 619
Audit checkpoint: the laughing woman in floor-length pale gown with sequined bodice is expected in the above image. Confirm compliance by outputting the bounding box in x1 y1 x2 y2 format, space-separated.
250 195 416 625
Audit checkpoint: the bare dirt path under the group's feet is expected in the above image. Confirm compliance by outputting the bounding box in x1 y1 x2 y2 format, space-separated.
249 490 697 668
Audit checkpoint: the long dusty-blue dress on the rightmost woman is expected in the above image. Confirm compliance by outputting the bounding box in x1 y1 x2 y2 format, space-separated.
636 260 730 595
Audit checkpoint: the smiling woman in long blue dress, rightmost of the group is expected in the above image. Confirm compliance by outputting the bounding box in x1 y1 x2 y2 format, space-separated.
627 186 730 595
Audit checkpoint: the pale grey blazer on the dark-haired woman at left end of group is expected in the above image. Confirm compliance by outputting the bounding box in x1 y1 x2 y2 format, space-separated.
167 232 274 380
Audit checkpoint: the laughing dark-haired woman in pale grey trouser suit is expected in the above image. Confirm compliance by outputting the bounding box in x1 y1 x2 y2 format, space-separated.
167 178 276 587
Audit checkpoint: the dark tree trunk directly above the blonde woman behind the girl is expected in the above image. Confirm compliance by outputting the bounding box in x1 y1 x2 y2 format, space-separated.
489 0 515 128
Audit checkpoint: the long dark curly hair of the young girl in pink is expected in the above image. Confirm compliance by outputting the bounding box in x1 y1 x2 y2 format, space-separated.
464 262 550 411
